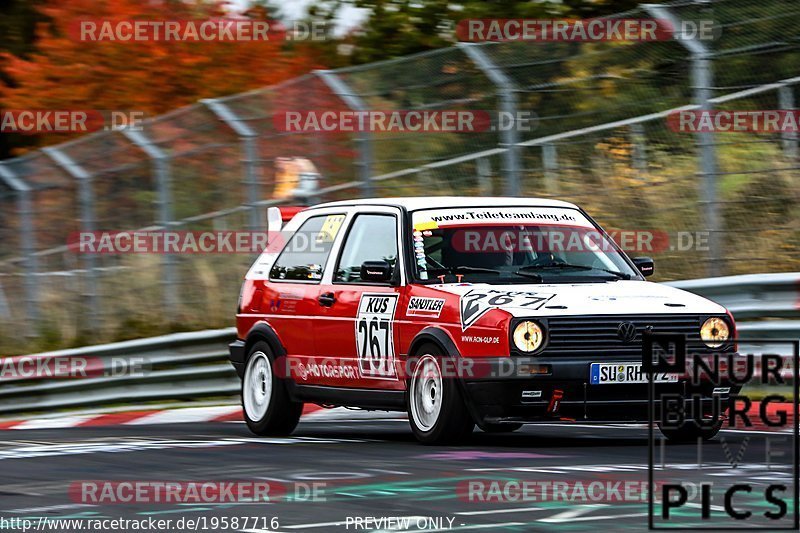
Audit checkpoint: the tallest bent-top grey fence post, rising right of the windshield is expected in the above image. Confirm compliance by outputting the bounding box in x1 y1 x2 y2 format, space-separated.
642 4 725 277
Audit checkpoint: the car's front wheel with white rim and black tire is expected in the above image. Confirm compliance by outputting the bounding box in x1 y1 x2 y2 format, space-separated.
406 344 475 444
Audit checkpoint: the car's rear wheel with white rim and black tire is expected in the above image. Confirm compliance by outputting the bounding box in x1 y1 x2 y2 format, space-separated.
242 341 303 436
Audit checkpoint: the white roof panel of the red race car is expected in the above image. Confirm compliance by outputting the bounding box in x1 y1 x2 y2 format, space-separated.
311 196 577 211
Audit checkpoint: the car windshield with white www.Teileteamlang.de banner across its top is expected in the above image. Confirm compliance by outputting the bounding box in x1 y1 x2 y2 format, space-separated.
412 207 639 284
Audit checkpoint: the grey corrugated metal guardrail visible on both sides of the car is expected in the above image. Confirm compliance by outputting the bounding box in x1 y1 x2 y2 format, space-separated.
0 273 800 414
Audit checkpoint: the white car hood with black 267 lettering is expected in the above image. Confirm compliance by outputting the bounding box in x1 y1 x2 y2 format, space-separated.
429 280 725 316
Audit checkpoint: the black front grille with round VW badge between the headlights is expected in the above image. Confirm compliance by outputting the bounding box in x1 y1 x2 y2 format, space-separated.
542 315 724 360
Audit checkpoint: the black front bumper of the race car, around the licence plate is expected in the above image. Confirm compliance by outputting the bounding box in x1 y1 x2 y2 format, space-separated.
463 357 741 423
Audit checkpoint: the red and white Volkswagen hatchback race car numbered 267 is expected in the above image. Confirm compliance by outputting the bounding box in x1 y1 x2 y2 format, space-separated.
230 197 735 443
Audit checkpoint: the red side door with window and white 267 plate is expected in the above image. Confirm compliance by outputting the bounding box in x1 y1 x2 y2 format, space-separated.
314 207 405 390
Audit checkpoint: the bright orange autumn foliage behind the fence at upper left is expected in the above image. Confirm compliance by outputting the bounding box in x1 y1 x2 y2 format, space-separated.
0 0 320 122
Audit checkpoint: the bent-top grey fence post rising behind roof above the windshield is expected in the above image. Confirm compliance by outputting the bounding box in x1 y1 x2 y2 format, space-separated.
458 42 522 196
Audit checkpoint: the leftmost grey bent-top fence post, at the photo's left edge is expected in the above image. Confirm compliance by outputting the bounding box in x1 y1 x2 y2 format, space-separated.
0 163 39 328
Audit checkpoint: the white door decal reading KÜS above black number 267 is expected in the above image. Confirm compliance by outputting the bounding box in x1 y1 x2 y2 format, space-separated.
356 293 397 380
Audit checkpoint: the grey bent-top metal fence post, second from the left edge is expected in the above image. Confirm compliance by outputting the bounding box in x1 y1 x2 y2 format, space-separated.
42 147 100 328
